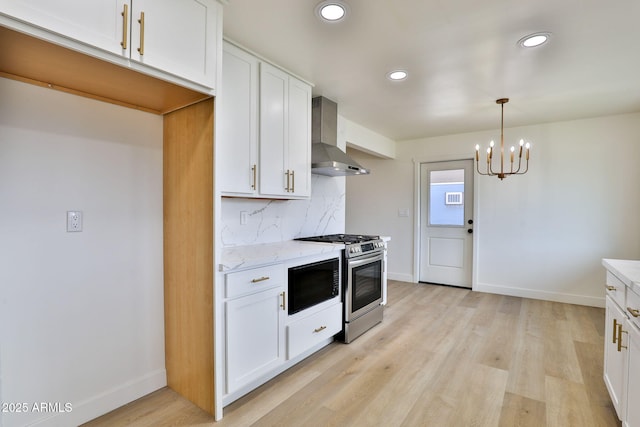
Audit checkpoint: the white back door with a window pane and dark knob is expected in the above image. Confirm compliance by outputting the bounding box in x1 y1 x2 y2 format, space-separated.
419 160 473 288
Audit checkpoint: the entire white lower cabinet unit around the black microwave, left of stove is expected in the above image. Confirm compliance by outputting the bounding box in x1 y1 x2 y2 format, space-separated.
225 252 342 406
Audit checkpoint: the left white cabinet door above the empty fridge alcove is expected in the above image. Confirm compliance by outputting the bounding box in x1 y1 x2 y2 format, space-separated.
0 0 131 56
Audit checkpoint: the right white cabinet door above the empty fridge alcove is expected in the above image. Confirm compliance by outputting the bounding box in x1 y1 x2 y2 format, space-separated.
131 0 221 88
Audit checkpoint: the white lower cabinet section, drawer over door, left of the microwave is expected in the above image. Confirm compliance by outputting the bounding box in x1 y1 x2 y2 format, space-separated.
225 265 287 393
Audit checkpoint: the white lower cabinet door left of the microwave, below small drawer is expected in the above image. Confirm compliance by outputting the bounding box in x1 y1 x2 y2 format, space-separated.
226 287 286 393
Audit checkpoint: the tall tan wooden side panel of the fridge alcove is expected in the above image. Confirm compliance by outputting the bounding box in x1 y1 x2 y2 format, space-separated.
163 99 214 414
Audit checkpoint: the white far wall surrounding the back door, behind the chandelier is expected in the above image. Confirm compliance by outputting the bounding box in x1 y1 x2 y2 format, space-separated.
346 113 640 306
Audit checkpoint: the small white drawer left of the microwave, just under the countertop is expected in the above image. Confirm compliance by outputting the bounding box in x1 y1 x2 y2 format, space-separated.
225 264 284 298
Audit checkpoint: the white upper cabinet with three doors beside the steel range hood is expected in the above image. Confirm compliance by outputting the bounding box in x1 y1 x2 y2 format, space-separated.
216 42 311 199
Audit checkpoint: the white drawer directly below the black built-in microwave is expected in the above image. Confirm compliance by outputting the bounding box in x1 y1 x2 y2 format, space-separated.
287 303 342 359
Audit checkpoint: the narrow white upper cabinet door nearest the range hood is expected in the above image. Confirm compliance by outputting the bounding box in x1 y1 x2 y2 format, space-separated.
286 77 311 197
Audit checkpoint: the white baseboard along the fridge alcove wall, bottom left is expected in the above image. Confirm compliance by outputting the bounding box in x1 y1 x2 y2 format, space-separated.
31 369 167 427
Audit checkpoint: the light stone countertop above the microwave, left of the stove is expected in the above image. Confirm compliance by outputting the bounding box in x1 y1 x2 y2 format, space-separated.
218 240 344 272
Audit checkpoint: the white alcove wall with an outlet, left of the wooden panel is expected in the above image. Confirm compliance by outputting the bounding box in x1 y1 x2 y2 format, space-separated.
0 79 166 427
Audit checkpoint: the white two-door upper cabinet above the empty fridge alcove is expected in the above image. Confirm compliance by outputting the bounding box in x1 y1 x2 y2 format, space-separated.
0 0 222 89
